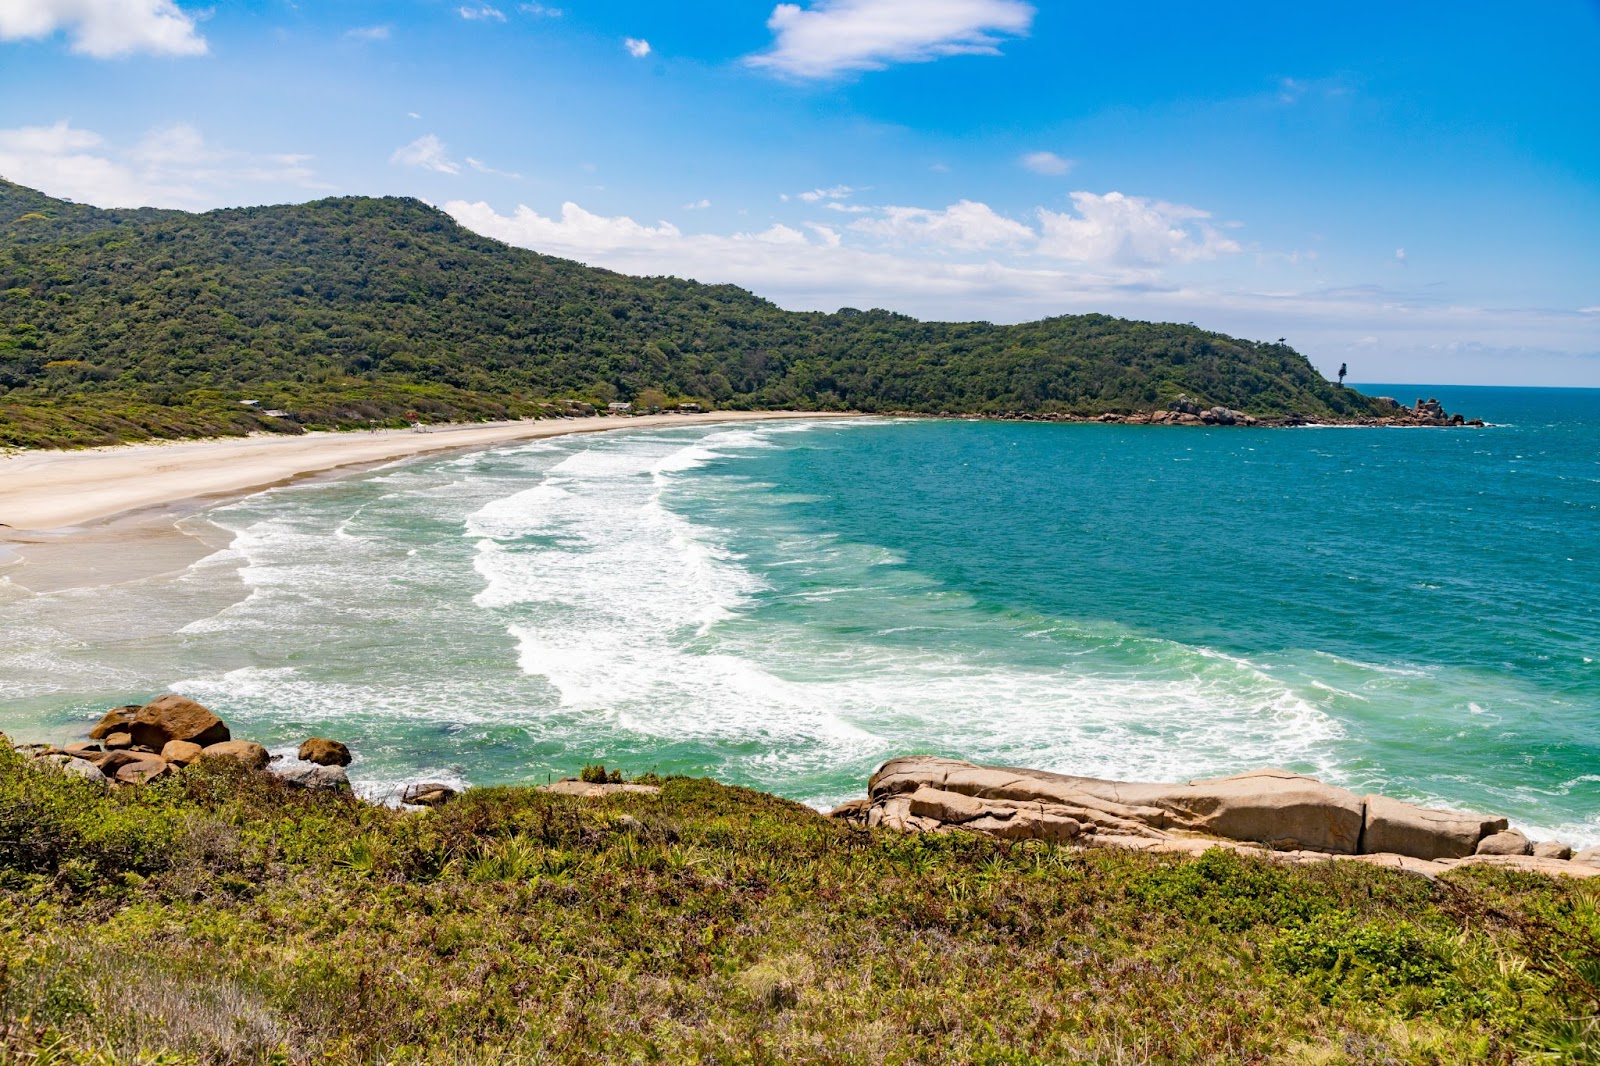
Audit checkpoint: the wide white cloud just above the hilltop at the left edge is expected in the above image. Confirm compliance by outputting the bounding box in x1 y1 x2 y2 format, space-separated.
0 122 326 208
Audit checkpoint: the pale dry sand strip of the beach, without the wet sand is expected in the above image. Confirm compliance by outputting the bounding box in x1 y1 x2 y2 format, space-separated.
0 411 838 531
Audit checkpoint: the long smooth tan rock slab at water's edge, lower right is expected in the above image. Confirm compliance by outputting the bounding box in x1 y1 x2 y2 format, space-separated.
832 755 1600 877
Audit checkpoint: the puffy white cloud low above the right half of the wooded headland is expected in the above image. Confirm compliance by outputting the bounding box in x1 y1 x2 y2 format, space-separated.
1037 192 1240 266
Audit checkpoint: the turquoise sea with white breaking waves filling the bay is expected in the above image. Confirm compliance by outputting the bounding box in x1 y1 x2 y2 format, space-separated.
0 386 1600 842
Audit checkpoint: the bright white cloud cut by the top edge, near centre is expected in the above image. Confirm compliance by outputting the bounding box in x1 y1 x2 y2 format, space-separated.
746 0 1034 78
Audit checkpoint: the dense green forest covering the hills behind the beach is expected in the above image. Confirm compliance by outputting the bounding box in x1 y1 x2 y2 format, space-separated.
0 181 1374 445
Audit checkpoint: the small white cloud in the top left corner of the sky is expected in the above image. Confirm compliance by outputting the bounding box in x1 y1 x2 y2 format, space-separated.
0 0 206 59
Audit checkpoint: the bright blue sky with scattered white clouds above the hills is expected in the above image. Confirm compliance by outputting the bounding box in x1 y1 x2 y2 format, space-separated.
0 0 1600 386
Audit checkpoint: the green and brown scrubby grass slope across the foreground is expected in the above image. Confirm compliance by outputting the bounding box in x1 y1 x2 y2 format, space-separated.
0 744 1600 1063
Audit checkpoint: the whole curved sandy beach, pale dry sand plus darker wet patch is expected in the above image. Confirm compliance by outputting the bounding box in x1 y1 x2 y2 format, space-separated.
0 411 840 592
